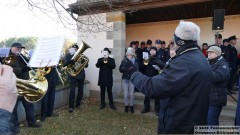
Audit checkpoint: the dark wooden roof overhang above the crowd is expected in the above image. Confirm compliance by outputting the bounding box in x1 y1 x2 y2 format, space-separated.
69 0 240 24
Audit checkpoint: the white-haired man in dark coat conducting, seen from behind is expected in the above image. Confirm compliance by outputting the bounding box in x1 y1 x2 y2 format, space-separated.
126 21 211 134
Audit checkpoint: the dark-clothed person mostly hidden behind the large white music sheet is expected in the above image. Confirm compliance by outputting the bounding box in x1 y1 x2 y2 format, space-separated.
41 67 58 122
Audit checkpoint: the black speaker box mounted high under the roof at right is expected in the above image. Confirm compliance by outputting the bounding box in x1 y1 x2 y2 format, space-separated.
212 9 225 30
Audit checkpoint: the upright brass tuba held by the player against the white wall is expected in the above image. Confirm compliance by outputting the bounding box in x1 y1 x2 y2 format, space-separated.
66 41 91 76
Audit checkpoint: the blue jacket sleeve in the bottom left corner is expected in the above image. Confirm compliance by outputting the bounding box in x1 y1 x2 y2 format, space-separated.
0 109 13 135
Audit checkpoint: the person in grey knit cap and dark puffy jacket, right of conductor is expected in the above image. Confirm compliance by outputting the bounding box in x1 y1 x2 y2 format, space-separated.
207 46 230 125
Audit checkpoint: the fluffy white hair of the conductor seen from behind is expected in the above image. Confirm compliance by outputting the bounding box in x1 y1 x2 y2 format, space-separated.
175 21 200 41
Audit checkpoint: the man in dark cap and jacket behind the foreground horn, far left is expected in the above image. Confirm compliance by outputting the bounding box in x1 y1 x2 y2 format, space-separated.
4 42 41 134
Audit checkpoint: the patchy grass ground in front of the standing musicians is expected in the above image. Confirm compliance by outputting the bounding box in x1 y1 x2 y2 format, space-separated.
20 103 157 135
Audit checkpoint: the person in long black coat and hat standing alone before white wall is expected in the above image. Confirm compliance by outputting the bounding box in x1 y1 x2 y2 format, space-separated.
96 48 116 110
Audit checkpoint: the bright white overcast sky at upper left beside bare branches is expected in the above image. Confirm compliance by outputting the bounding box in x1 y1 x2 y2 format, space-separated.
0 0 77 40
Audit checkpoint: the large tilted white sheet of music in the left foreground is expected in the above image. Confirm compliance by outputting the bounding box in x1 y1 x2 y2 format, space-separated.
29 36 65 67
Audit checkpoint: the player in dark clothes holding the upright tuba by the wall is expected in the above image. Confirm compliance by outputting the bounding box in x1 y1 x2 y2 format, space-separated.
63 44 88 113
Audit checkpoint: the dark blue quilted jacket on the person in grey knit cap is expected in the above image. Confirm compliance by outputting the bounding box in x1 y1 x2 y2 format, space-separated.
209 57 230 106
